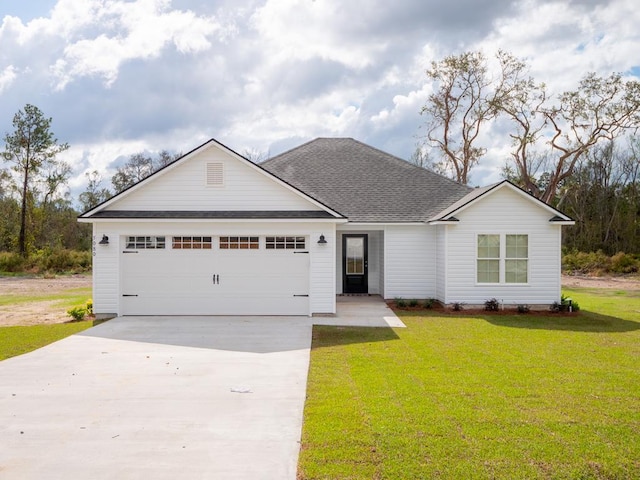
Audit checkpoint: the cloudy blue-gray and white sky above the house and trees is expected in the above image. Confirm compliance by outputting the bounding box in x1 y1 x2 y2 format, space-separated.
0 0 640 199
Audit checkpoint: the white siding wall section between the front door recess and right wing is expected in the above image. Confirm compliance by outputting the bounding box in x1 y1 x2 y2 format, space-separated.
384 225 436 299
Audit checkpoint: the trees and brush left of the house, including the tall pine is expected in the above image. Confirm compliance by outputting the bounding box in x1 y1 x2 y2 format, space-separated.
0 104 181 257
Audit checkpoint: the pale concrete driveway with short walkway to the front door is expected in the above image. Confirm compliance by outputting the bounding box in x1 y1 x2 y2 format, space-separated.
0 300 400 480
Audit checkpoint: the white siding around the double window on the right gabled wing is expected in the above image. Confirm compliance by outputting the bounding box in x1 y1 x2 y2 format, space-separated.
440 187 561 305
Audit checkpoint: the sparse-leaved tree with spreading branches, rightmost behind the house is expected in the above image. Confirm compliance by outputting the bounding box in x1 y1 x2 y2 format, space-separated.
499 68 640 203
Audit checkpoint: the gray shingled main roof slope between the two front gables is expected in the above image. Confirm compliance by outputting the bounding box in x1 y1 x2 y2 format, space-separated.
260 138 472 222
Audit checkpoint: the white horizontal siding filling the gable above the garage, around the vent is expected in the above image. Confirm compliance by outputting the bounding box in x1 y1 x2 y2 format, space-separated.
109 146 319 211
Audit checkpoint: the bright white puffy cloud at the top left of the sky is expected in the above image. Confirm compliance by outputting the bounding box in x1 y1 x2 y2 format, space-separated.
40 0 233 90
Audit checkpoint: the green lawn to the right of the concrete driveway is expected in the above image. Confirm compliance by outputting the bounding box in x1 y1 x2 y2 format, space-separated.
298 289 640 480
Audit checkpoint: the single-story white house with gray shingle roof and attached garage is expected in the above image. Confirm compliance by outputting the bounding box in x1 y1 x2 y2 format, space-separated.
79 138 573 315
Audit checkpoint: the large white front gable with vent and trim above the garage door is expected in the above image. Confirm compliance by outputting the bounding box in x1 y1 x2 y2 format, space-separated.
80 140 341 218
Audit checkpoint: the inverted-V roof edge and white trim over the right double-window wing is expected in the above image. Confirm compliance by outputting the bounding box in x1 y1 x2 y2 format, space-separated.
429 180 574 225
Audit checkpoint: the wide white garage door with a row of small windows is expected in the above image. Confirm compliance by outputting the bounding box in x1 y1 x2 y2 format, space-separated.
121 236 309 315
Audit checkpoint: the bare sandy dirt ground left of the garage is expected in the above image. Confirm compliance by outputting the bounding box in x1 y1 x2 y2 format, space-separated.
0 275 91 327
